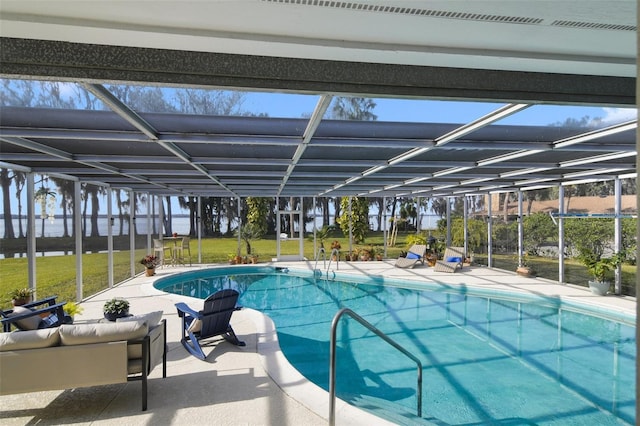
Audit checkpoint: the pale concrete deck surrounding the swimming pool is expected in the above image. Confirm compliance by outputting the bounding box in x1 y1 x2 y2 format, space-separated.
0 260 636 425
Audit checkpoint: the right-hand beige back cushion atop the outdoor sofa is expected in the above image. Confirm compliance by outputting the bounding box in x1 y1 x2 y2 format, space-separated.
60 321 149 345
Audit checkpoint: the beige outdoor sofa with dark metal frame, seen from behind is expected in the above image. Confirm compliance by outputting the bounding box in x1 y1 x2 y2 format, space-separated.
0 312 167 411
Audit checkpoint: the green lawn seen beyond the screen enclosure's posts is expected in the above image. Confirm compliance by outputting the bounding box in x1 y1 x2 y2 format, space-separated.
0 233 636 308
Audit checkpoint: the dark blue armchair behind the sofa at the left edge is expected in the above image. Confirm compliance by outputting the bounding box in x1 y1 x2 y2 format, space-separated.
0 296 72 332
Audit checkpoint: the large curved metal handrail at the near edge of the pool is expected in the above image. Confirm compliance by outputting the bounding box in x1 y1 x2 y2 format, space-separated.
329 308 422 426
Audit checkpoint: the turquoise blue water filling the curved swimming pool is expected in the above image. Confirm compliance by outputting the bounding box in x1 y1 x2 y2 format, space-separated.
155 266 636 425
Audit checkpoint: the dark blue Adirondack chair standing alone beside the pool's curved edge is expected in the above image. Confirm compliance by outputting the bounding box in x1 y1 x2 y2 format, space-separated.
176 289 245 360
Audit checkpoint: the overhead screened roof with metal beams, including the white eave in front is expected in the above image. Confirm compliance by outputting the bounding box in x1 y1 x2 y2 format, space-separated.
0 0 637 197
